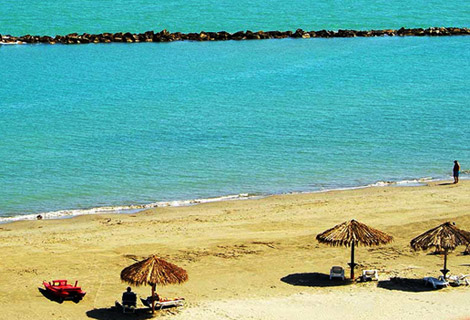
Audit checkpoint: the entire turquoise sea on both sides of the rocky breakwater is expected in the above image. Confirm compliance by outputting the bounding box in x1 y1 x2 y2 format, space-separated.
0 0 470 217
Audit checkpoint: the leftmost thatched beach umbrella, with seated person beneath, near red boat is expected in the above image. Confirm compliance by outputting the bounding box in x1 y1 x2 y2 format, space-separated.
121 255 188 312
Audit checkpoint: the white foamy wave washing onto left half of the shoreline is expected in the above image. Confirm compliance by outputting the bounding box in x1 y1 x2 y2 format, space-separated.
0 193 260 223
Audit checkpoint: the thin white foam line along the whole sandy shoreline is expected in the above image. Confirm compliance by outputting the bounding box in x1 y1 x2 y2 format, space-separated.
0 176 462 225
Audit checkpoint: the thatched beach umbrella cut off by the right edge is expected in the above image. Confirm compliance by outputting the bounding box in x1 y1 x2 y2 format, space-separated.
410 222 470 277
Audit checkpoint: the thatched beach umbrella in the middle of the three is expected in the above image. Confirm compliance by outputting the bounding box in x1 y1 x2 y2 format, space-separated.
317 220 393 279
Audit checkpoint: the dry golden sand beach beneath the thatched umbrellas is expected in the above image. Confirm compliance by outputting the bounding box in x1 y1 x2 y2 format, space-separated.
0 181 470 319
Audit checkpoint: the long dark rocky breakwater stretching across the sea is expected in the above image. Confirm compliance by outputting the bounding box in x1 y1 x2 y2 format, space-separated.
0 27 470 44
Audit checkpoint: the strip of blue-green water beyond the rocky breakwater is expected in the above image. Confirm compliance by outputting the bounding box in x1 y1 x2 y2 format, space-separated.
0 0 470 36
